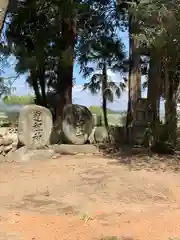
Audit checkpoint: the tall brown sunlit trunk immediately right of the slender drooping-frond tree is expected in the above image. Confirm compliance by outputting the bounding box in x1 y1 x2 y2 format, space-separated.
117 0 141 127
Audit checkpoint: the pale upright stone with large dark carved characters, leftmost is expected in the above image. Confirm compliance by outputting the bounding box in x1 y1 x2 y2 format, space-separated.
18 104 52 149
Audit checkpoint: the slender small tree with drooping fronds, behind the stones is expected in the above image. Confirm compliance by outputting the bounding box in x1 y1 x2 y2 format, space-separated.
78 35 125 128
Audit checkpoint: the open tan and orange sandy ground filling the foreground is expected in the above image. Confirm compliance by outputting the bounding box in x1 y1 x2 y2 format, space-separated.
0 156 180 240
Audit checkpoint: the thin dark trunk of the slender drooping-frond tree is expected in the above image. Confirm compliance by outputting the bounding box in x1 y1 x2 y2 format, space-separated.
102 63 108 129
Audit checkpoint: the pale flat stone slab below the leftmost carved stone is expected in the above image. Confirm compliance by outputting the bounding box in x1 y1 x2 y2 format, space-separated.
6 146 54 162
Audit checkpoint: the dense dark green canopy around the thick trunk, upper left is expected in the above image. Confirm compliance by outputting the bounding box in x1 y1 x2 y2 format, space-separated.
3 0 118 107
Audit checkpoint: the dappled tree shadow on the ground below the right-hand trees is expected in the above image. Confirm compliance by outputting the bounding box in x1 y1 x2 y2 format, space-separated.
99 144 180 172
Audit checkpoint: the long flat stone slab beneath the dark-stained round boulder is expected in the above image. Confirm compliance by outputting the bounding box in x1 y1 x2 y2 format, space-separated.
52 144 99 154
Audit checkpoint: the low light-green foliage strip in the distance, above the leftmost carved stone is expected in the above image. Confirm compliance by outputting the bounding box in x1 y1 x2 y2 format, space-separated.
3 95 34 105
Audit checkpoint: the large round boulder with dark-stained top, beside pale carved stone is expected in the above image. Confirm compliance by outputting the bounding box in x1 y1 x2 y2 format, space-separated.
62 104 94 145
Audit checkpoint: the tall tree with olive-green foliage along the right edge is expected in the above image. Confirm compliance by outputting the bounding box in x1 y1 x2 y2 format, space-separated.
130 0 180 143
